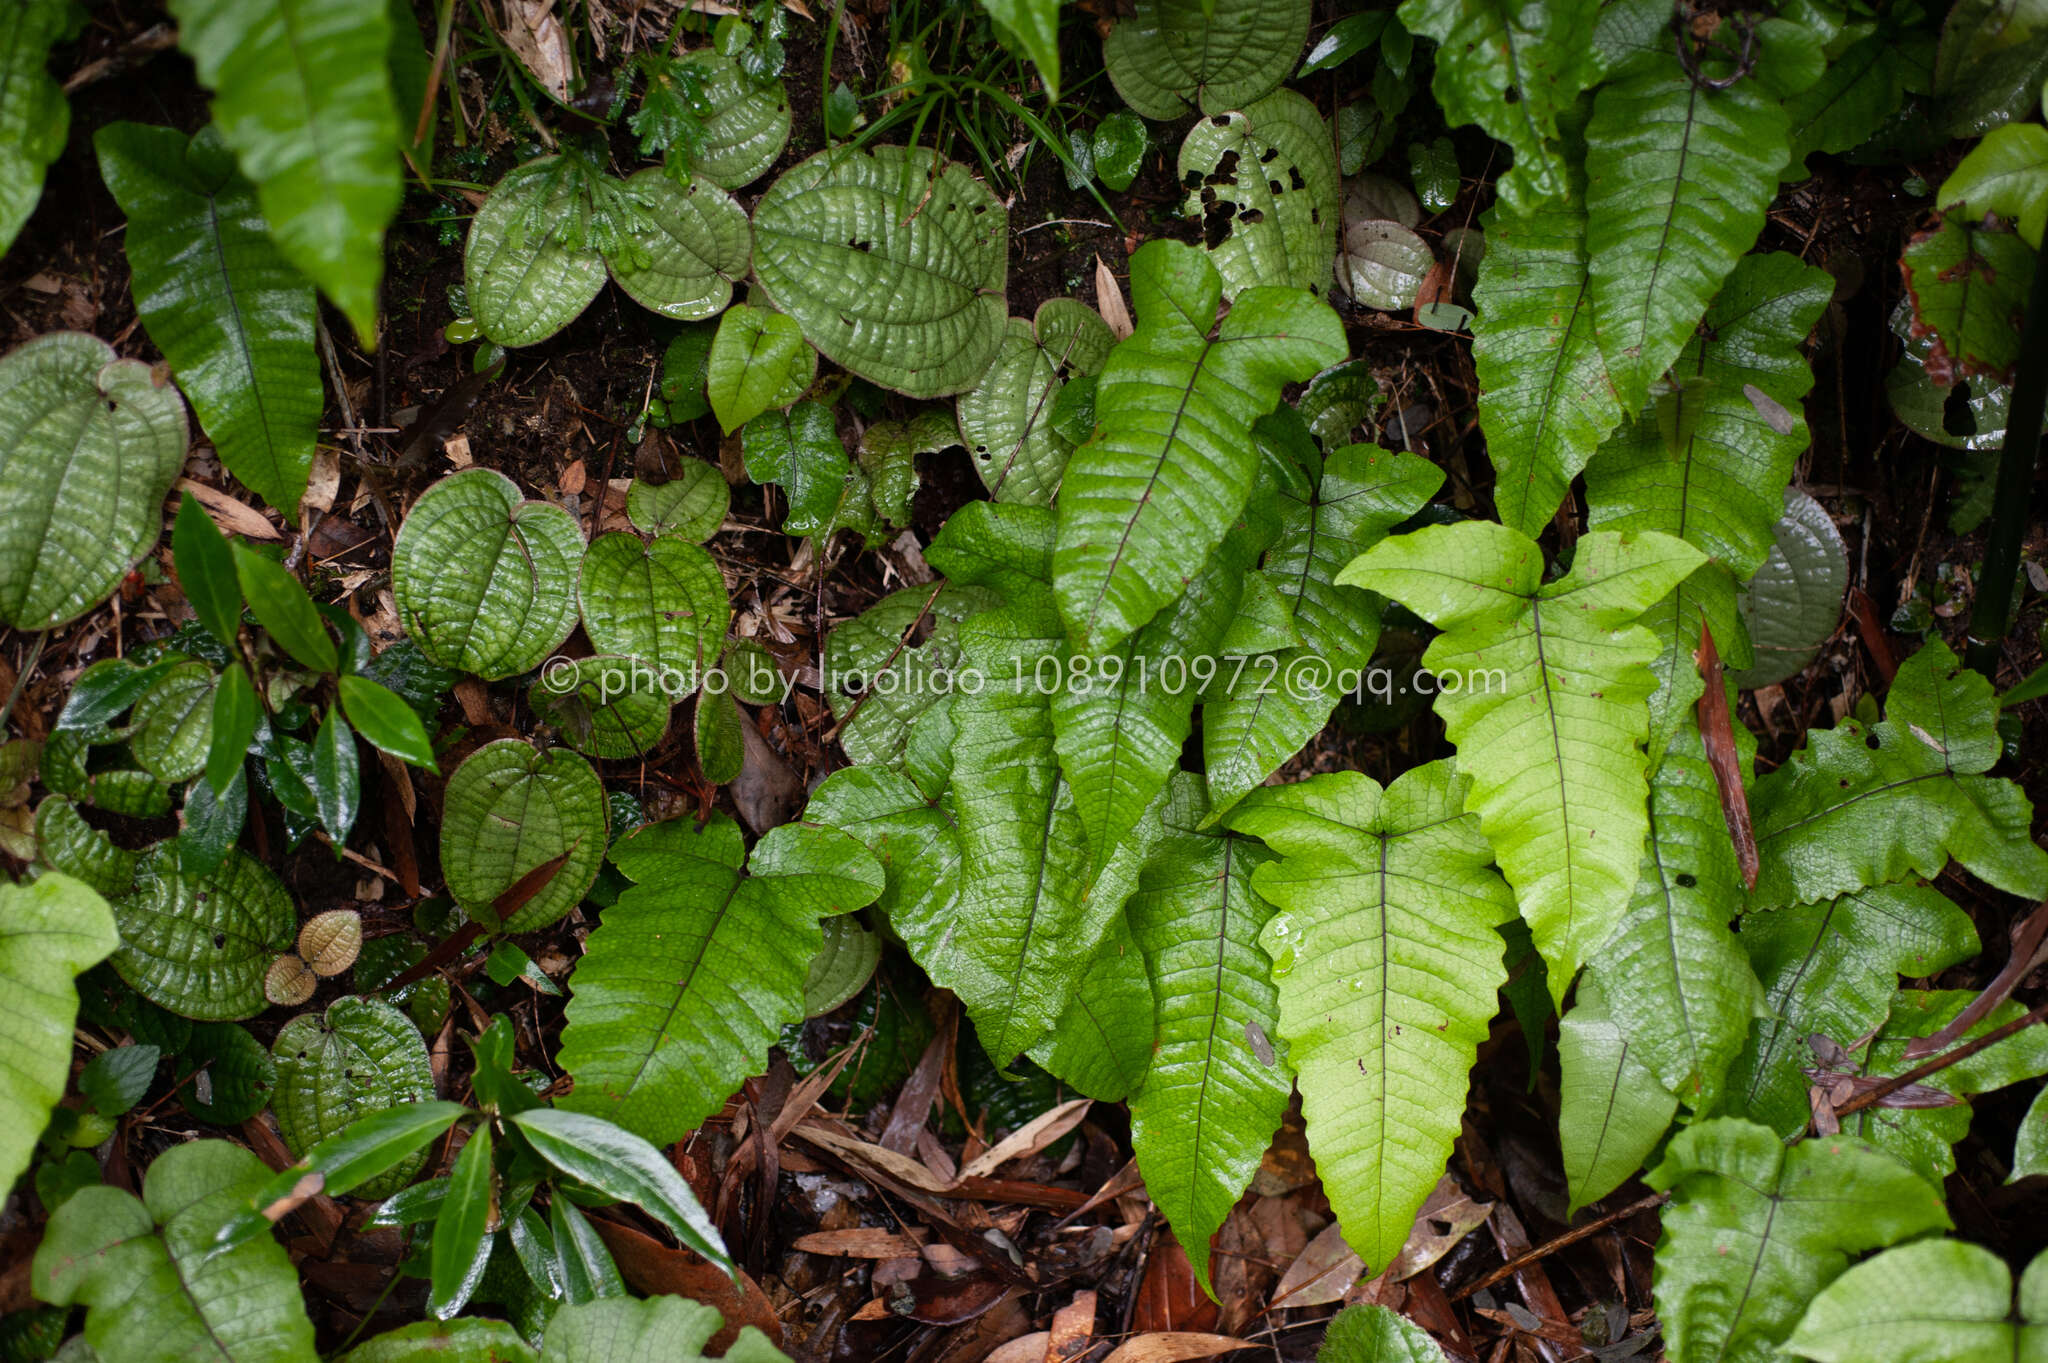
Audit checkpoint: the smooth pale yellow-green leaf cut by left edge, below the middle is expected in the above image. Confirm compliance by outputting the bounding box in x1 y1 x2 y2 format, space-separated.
0 872 121 1189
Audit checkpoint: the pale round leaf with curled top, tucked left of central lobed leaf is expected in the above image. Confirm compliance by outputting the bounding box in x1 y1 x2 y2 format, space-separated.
958 299 1116 505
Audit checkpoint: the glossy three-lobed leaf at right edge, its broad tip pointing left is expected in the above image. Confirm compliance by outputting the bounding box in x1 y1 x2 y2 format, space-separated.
1749 639 2048 909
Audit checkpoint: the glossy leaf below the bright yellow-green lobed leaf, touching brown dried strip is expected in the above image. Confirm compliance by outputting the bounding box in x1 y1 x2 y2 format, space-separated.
1581 727 1763 1111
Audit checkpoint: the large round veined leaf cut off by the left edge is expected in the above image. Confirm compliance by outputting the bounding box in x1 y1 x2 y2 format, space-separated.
0 332 186 630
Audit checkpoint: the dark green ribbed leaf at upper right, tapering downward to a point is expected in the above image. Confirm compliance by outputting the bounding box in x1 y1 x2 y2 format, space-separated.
1585 51 1788 411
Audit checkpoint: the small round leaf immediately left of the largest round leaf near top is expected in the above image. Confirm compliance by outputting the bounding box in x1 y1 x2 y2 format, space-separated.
608 166 754 321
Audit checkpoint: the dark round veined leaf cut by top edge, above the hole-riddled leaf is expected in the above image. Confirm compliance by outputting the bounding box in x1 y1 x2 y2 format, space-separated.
1102 0 1311 121
